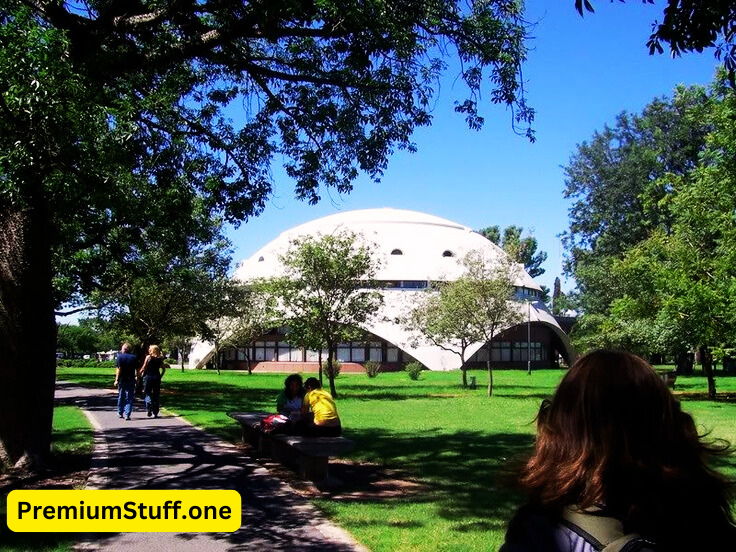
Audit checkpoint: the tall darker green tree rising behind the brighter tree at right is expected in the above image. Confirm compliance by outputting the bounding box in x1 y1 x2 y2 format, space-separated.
562 83 718 314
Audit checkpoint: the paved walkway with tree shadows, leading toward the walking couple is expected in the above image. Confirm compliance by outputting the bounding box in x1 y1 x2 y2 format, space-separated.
56 382 365 552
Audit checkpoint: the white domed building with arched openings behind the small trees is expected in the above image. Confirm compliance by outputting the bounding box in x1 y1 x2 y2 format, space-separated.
190 208 573 372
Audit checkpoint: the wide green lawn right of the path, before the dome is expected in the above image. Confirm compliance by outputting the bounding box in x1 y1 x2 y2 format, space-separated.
59 368 736 551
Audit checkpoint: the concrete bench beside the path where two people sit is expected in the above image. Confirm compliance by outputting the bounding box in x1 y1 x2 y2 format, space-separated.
228 412 355 482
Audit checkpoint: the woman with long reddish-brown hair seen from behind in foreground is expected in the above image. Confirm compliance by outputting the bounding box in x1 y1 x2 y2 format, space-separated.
502 350 736 552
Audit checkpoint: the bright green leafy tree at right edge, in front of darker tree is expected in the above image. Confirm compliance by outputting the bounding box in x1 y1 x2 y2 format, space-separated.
564 79 736 397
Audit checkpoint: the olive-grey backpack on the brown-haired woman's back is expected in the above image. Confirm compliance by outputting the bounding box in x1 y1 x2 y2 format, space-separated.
562 507 653 552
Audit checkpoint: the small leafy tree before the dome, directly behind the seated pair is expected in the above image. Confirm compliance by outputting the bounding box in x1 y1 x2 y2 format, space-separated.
268 231 383 397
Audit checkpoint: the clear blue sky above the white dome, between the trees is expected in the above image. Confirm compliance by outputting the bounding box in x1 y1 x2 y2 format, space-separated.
228 0 717 289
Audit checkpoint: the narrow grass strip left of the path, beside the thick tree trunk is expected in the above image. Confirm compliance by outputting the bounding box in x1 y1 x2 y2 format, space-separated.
0 406 93 552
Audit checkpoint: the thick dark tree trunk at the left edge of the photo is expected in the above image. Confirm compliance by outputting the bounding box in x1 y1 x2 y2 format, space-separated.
0 201 56 468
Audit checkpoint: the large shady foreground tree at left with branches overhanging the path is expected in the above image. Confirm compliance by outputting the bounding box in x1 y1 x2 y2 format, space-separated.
0 0 534 464
